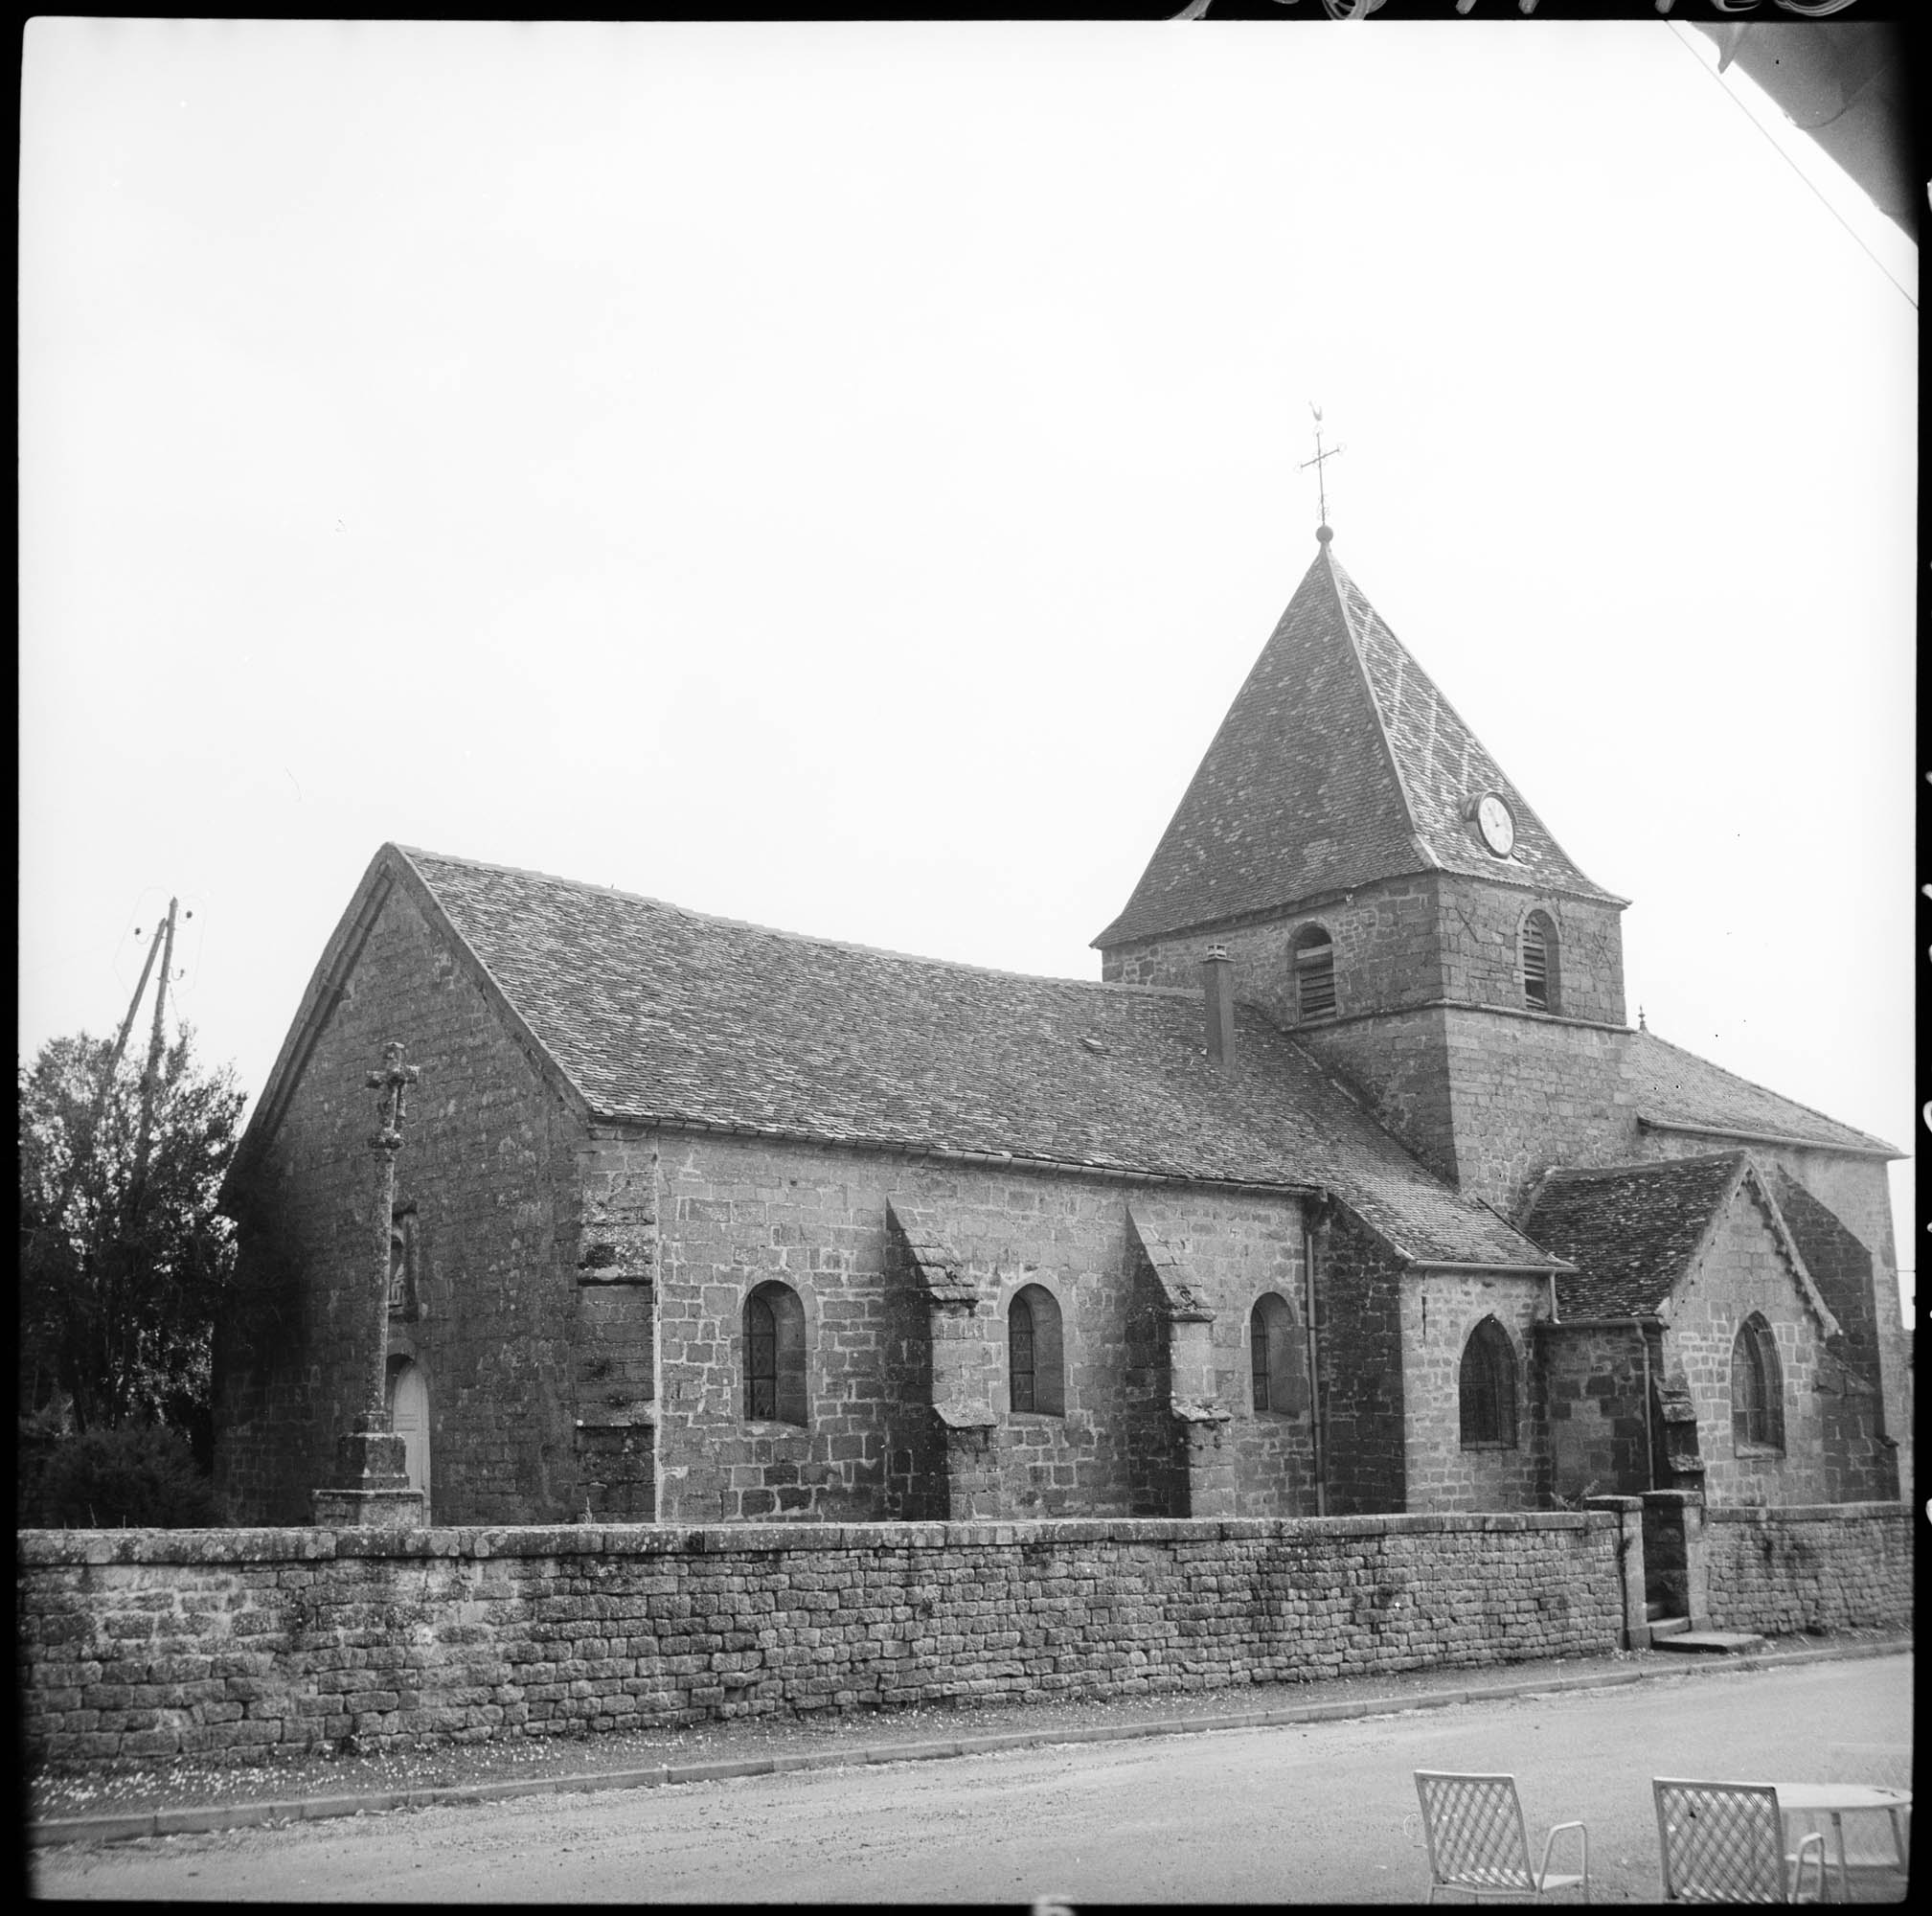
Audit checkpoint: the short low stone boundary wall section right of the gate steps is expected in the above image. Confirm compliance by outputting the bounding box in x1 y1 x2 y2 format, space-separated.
1704 1503 1913 1636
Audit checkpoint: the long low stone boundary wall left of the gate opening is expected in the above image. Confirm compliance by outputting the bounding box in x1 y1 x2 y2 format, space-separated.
19 1513 1623 1766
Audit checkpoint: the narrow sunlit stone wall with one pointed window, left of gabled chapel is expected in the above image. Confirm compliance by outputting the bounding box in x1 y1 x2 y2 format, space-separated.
1400 1271 1550 1511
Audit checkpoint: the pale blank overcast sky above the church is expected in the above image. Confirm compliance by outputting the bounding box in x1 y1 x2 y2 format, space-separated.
19 15 1917 1312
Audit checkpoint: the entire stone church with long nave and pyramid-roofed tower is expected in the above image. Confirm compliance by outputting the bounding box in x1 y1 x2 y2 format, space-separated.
216 527 1911 1524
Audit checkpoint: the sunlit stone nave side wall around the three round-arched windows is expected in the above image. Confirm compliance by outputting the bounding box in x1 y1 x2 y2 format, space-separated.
657 1133 1310 1522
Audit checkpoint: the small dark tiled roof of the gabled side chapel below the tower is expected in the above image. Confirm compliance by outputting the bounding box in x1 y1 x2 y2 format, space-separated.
1522 1152 1744 1317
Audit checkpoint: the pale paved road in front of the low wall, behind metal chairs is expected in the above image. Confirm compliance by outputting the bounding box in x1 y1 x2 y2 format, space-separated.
33 1655 1913 1905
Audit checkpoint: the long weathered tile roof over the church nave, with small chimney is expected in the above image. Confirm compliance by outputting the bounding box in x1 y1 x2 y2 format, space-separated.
392 846 1550 1269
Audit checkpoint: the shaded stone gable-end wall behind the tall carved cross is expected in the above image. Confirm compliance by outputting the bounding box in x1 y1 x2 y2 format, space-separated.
215 890 581 1524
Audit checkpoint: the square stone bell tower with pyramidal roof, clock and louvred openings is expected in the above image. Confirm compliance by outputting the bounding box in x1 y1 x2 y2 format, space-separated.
1094 523 1628 1211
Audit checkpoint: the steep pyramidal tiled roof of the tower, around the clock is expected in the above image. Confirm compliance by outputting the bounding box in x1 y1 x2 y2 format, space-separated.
1094 527 1626 948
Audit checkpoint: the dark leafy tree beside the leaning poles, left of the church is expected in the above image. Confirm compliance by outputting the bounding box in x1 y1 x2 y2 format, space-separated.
19 1028 243 1448
